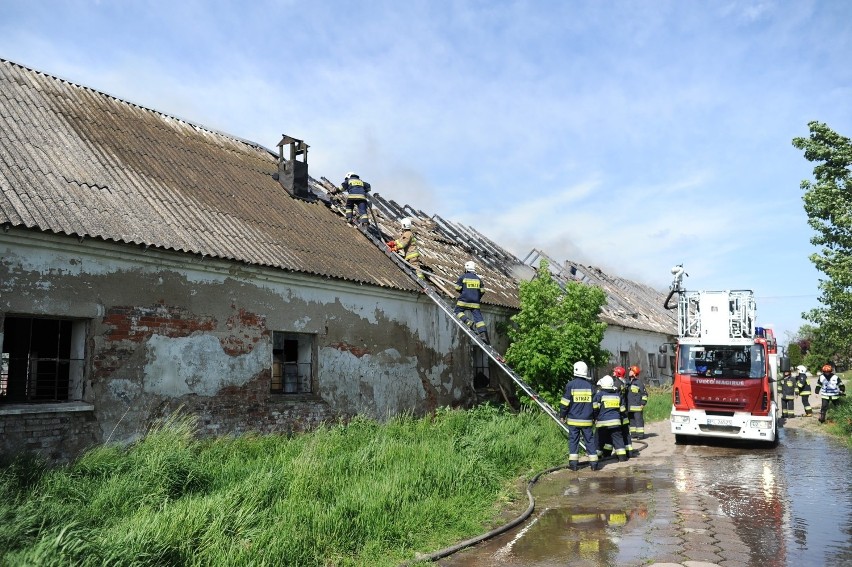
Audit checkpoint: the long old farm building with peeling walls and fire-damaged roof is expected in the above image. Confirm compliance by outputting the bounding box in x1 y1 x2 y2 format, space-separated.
0 60 673 460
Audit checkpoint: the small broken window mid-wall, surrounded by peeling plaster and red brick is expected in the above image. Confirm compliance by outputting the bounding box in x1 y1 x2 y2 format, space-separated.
271 331 314 394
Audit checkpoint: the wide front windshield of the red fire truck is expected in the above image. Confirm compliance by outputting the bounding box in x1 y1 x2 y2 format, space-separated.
678 344 766 378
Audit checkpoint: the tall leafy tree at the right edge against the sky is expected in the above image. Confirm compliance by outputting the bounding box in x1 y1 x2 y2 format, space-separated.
793 122 852 364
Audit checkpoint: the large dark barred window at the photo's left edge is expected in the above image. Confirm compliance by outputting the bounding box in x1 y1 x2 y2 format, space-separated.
0 316 86 403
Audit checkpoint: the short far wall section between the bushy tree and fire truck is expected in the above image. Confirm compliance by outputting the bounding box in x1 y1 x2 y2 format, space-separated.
601 324 674 385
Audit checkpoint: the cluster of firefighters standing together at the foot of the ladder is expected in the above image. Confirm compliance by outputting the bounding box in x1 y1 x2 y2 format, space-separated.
559 361 648 471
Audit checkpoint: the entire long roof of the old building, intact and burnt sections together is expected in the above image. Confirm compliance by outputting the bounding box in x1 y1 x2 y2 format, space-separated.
0 59 677 335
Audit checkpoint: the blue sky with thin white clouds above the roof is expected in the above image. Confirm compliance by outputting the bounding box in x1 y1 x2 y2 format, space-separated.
0 0 852 344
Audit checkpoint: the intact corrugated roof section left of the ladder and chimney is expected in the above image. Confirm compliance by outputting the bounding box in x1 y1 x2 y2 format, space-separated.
0 59 418 290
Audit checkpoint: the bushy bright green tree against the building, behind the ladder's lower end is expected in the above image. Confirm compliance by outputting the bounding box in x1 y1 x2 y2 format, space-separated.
506 260 610 405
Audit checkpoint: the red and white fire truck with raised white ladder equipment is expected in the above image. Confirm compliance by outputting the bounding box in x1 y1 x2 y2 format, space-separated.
665 266 777 444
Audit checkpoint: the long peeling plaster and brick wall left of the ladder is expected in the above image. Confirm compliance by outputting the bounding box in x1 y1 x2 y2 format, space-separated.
0 229 494 462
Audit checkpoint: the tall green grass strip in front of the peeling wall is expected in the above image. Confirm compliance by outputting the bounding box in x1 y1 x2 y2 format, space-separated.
5 406 566 566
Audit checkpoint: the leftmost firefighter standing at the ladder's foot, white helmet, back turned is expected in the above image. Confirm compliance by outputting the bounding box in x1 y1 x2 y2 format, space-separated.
559 360 600 471
